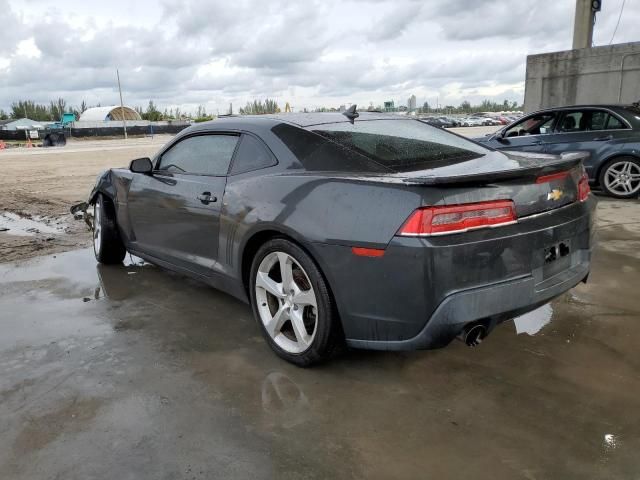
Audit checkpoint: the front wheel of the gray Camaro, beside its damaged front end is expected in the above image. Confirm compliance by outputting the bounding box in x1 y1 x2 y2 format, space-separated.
93 193 127 265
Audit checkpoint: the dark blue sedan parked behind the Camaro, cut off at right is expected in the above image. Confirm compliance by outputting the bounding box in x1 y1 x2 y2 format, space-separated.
477 104 640 198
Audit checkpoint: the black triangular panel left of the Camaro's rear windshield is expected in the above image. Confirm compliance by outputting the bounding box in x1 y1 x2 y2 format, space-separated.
271 123 389 173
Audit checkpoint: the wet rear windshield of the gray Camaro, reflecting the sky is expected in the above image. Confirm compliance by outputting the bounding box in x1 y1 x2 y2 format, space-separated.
309 120 487 172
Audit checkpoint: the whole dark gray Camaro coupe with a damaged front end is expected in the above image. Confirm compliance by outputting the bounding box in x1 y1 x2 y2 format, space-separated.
84 111 595 365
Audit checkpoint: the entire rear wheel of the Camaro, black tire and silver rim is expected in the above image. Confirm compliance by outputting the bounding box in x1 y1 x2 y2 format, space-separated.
250 238 341 367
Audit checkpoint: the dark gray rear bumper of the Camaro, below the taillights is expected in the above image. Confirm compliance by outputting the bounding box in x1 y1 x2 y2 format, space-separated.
311 198 596 350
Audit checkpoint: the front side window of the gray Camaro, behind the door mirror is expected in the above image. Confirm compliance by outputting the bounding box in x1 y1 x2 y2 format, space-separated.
158 135 238 175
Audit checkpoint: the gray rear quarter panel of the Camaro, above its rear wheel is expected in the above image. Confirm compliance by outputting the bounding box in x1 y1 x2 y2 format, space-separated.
220 174 430 267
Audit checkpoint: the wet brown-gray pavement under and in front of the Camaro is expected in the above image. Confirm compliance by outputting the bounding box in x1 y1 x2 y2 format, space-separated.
0 202 640 480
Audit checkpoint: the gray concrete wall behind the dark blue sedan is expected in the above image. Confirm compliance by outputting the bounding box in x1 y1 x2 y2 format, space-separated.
524 42 640 113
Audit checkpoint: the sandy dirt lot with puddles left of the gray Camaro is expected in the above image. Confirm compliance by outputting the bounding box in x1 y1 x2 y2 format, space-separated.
0 135 171 262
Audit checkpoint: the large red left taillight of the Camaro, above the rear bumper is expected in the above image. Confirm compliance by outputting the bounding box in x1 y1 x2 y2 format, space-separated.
398 200 518 236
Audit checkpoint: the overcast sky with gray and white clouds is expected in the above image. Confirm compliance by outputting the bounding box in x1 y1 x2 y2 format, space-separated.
0 0 640 113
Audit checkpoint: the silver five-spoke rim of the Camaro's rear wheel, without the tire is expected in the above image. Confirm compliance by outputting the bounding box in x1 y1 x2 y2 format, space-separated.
255 252 318 354
